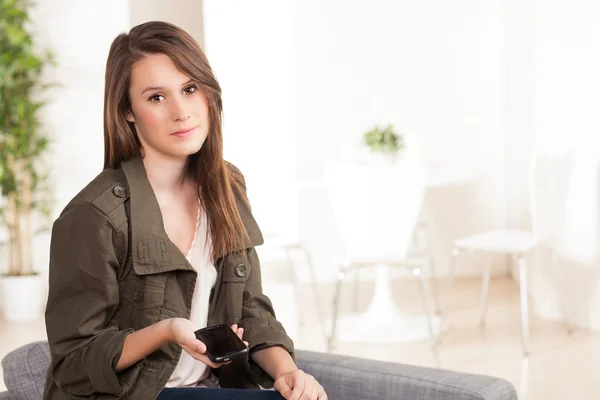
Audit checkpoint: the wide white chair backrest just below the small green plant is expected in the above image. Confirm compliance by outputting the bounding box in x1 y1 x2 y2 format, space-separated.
325 161 425 262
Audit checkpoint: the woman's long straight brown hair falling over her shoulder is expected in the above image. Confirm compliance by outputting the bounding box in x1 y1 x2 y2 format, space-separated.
104 21 248 256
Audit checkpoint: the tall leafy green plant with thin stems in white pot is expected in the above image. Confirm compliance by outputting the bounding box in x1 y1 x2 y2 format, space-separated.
0 0 52 321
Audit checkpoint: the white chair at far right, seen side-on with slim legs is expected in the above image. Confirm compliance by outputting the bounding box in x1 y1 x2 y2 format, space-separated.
449 151 575 356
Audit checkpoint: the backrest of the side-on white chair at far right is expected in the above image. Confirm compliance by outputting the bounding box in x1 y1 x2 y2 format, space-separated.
529 150 575 246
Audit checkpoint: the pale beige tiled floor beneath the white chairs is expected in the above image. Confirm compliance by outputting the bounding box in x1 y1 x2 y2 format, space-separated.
0 278 600 400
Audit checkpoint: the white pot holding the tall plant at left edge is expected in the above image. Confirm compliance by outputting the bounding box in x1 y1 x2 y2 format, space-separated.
0 274 44 322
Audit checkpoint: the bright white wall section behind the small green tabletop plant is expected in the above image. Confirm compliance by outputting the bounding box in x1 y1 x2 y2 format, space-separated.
294 0 504 175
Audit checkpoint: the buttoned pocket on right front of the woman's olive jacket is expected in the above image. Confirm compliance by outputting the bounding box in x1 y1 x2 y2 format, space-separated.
223 256 252 324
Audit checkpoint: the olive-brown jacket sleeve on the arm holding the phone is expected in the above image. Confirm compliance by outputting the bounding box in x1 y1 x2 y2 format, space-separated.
46 203 132 396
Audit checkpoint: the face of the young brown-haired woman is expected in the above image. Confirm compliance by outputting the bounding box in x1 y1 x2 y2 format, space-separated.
127 54 209 160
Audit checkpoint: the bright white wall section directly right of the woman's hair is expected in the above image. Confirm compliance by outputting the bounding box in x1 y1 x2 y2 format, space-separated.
204 0 297 241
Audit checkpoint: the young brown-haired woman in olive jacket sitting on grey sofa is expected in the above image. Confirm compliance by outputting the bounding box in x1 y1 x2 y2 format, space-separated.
44 22 327 400
